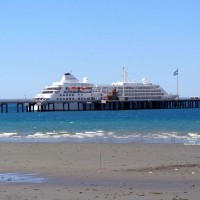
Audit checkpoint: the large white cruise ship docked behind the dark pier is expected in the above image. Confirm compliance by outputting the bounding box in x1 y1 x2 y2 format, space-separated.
34 68 176 110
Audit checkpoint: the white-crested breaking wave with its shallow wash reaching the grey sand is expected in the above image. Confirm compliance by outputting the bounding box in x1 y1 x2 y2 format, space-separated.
0 130 200 144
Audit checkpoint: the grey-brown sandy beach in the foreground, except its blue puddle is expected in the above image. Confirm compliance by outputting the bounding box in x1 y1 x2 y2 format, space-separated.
0 143 200 200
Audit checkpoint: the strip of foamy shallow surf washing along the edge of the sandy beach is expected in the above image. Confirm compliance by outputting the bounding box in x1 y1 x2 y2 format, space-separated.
0 134 200 145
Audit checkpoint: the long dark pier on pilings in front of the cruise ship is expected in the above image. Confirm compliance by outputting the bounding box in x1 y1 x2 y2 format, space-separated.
0 98 200 113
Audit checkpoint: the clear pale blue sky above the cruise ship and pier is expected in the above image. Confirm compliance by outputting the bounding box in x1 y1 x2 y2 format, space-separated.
0 0 200 98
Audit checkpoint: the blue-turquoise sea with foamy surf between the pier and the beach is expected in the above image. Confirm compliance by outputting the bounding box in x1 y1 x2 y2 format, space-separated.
0 109 200 144
